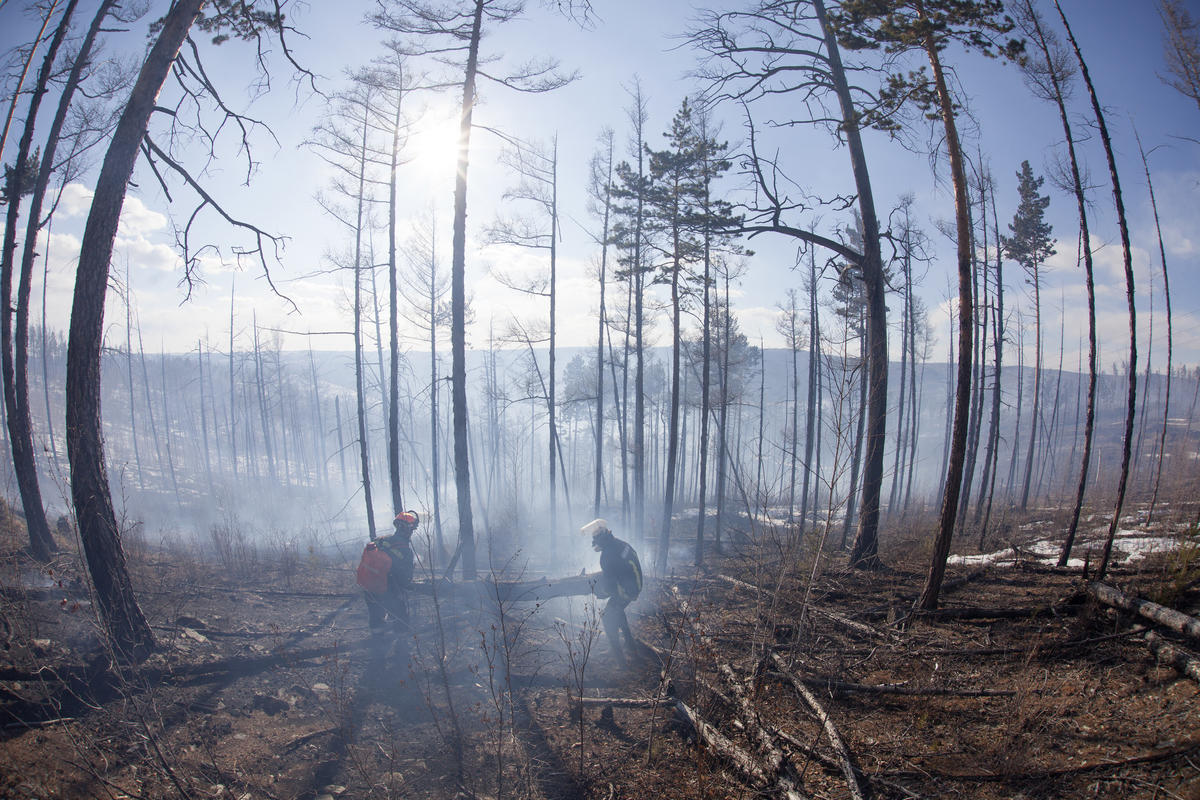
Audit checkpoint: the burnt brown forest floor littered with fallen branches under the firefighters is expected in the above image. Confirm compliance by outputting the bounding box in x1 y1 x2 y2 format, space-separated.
0 509 1200 800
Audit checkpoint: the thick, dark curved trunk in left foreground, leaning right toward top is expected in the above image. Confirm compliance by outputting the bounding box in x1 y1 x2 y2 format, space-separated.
67 0 203 661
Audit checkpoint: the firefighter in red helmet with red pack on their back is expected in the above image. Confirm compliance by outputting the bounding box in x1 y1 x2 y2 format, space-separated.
358 511 420 655
